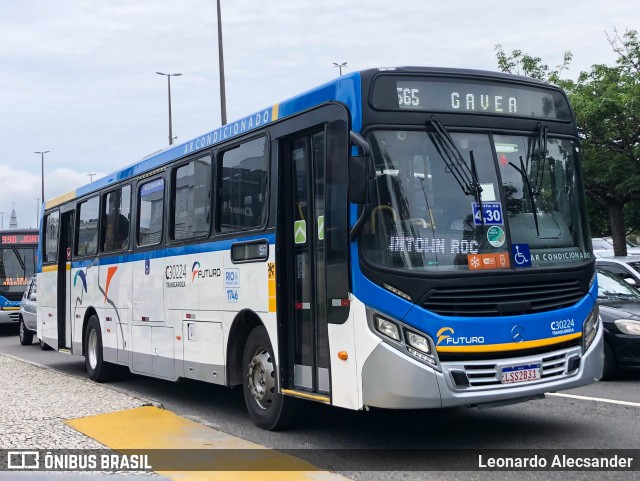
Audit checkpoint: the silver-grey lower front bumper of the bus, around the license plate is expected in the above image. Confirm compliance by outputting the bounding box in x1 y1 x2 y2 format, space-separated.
362 324 604 409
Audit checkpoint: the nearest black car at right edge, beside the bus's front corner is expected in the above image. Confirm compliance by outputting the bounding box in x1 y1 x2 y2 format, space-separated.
598 269 640 380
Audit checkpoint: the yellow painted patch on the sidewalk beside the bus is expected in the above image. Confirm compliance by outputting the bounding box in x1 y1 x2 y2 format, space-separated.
65 406 348 481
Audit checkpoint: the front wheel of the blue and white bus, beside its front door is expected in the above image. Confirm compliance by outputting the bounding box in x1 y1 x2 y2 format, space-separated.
242 326 295 431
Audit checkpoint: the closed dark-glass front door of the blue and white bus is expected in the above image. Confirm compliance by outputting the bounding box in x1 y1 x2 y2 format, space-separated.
283 130 330 395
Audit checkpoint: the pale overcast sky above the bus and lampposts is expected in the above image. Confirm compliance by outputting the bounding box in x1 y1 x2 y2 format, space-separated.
0 0 640 228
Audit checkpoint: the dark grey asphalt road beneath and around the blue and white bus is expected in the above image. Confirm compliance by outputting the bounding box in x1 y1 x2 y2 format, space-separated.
0 326 640 480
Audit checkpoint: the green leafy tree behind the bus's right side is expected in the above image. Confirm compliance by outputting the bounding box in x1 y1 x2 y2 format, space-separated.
496 30 640 255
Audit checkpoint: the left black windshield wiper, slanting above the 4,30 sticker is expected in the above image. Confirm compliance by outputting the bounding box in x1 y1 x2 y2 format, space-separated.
427 115 484 210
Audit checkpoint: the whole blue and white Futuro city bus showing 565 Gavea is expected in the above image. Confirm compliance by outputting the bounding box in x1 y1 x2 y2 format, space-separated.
38 68 603 429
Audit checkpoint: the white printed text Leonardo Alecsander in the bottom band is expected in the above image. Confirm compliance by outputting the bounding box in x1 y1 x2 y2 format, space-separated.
478 454 634 470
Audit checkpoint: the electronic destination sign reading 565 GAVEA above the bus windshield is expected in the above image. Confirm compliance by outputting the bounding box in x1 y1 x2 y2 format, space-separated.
372 76 571 120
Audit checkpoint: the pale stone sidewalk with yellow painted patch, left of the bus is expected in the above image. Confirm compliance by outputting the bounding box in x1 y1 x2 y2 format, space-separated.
0 354 347 481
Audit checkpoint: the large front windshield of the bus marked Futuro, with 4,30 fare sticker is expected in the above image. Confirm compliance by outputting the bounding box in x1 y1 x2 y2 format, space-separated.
362 130 591 271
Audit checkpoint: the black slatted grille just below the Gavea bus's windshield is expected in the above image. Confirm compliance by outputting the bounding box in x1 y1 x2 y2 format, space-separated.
424 281 586 317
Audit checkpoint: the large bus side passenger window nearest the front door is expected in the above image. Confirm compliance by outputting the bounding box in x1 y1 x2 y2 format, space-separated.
218 137 269 232
